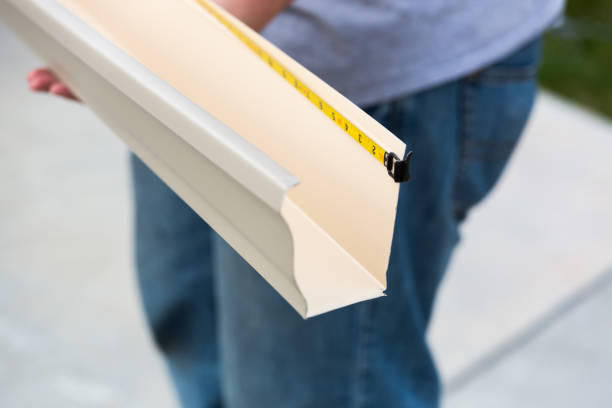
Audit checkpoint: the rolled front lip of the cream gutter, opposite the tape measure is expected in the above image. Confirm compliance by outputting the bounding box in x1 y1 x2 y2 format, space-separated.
11 0 299 210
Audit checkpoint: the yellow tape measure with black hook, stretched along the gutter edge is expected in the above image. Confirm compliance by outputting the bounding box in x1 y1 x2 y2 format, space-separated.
196 0 412 183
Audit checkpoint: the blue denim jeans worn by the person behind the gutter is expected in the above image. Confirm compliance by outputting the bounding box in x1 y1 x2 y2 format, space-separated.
132 40 539 408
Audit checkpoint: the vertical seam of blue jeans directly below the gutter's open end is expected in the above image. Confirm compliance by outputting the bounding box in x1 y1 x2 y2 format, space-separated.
352 304 374 408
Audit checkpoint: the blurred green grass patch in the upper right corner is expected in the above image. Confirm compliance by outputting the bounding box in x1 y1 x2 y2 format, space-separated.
540 0 612 117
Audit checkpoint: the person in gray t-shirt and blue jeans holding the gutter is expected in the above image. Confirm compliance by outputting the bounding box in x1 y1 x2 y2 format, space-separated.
28 0 563 408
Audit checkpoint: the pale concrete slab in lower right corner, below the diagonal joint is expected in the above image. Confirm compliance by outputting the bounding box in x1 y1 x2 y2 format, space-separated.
447 270 612 408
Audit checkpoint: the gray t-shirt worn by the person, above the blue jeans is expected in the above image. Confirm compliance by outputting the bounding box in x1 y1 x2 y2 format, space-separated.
262 0 564 106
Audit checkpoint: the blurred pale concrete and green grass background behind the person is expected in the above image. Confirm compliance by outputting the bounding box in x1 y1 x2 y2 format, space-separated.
0 0 612 408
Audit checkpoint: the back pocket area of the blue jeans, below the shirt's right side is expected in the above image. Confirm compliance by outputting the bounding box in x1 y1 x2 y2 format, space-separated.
453 39 540 221
